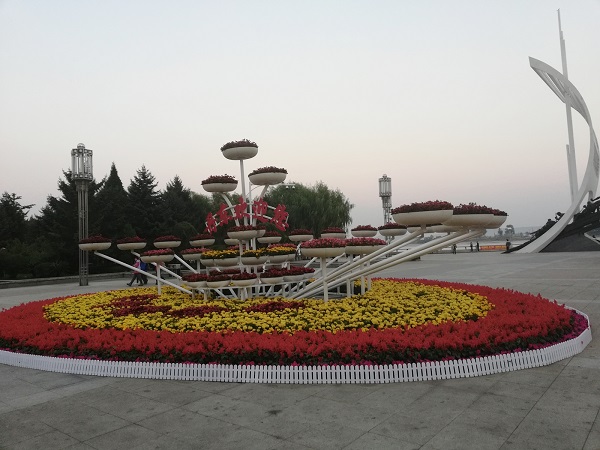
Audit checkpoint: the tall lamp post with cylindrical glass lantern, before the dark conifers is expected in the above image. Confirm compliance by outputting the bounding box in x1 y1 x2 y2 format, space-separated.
71 144 94 286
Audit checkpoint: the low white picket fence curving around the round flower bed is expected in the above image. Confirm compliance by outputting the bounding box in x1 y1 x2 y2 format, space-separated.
0 308 592 384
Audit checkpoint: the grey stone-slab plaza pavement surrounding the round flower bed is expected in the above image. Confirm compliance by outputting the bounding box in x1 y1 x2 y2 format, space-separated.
0 252 600 450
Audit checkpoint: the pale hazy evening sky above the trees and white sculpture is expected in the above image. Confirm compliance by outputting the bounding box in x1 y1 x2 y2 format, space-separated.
0 0 600 232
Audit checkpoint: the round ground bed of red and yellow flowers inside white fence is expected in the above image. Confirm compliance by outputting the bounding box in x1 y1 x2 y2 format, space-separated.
0 279 588 364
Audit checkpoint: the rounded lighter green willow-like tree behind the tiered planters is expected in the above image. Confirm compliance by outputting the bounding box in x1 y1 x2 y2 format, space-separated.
265 182 354 235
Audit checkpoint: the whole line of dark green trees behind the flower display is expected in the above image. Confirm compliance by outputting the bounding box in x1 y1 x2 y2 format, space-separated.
0 163 353 279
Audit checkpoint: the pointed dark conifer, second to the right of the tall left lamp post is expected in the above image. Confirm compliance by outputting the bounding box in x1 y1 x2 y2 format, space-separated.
127 166 164 239
